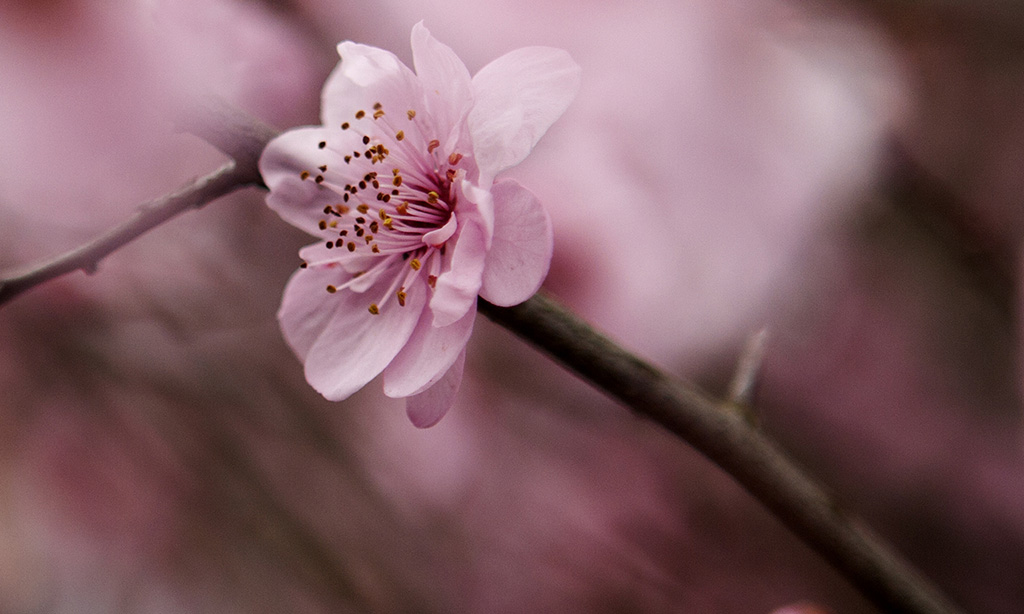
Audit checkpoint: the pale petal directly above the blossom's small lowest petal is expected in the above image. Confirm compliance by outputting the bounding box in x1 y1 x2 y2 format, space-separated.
384 308 476 398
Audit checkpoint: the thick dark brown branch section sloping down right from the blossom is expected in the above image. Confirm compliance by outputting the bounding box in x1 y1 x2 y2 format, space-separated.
478 295 958 614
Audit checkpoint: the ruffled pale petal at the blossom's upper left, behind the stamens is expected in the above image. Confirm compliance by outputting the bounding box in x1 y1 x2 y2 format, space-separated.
321 41 423 129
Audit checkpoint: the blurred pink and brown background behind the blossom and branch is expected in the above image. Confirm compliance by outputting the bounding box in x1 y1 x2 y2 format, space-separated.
0 0 1024 614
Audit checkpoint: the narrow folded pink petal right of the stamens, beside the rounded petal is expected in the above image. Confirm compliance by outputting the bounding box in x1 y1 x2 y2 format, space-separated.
430 219 487 326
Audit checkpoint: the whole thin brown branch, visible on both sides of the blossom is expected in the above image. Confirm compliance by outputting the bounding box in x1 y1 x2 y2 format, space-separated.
0 104 958 614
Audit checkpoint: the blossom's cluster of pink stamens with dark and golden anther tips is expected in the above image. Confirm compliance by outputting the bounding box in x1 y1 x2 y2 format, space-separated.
300 102 465 314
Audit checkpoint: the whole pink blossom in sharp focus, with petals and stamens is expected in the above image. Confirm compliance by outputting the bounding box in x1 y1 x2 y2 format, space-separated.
260 24 580 427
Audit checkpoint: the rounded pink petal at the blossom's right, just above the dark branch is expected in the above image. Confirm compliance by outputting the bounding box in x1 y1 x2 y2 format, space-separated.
480 180 554 307
